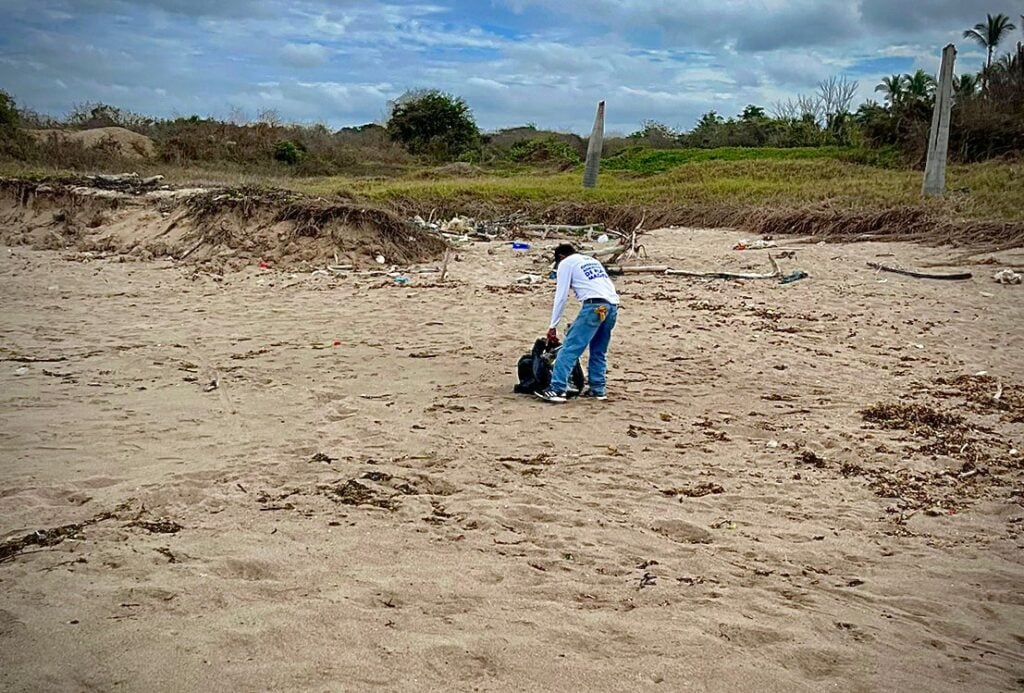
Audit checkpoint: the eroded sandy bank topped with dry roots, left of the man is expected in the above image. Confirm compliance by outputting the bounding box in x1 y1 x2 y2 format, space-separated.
0 179 445 271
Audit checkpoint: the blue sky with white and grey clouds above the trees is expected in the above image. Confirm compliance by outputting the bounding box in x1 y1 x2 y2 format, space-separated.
0 0 1024 133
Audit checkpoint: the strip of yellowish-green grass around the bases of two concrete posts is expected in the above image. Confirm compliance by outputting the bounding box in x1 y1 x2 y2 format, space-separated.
282 157 1024 221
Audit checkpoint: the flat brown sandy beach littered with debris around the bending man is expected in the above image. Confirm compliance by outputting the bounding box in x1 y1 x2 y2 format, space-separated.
0 229 1024 692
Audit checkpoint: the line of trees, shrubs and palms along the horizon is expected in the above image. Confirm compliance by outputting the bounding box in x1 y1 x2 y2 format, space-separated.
0 14 1024 169
